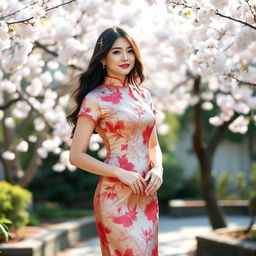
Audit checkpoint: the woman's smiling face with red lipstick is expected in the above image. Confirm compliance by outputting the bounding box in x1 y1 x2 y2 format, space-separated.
102 37 135 80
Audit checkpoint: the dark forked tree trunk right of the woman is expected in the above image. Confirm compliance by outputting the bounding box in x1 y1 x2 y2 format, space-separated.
193 76 227 229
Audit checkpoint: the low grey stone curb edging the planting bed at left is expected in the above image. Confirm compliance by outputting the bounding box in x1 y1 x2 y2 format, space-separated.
0 217 97 256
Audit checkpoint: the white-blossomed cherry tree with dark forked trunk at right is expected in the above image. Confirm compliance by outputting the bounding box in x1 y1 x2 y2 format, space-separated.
164 0 256 228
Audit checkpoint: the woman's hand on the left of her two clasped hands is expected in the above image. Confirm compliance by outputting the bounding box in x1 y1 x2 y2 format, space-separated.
117 169 147 196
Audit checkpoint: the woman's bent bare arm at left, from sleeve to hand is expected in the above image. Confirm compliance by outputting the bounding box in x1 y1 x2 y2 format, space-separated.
69 116 146 194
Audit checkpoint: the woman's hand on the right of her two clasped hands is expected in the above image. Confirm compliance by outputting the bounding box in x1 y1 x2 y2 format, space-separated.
145 166 163 196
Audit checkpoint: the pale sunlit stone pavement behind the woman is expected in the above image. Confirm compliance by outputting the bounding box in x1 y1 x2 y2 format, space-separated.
58 216 249 256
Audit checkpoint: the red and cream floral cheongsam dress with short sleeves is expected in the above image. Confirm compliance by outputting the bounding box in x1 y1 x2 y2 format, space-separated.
78 76 159 256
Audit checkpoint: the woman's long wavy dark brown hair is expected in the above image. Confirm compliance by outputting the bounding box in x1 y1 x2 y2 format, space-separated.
66 27 144 138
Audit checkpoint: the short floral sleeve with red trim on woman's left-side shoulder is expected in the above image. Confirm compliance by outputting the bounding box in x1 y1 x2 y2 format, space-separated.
77 93 101 123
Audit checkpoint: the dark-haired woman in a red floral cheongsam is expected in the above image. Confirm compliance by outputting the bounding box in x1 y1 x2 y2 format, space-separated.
67 27 163 256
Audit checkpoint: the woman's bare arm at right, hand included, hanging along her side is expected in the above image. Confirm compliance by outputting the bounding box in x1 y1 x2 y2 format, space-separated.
145 126 163 195
